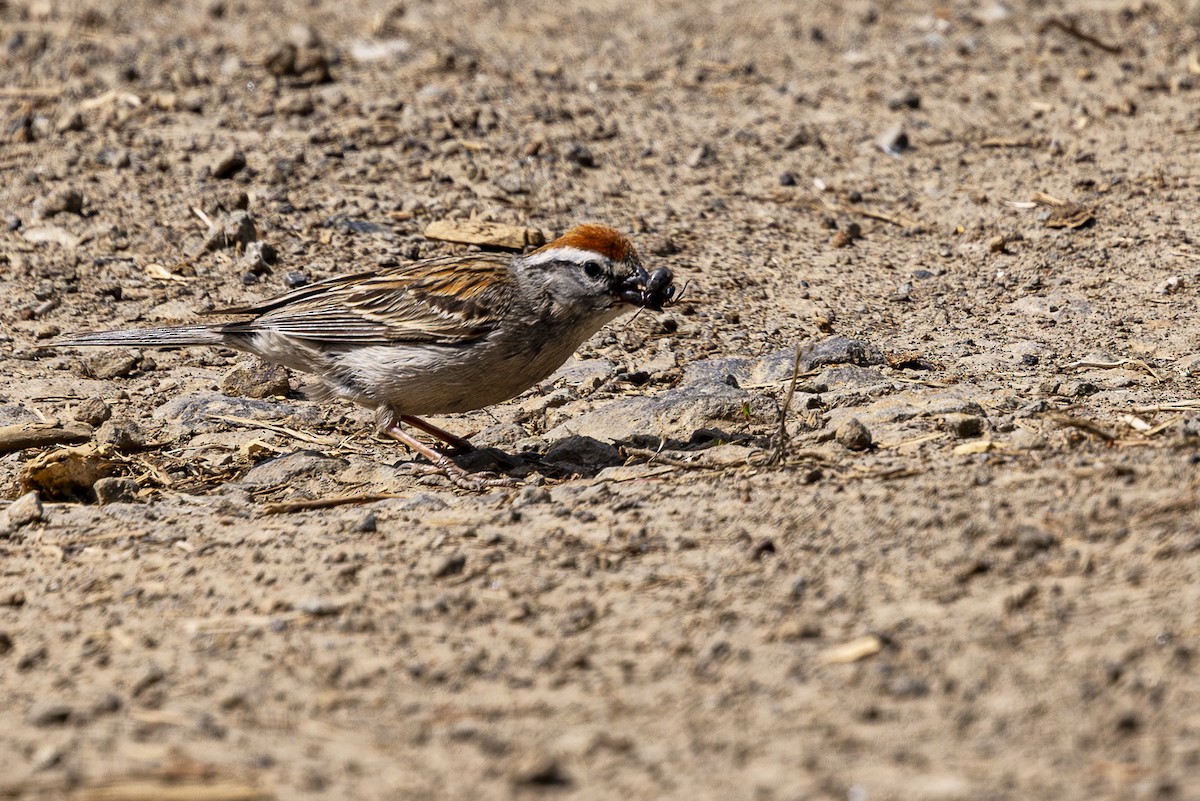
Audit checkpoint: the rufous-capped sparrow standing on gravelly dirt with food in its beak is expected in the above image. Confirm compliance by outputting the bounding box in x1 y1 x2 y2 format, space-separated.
53 224 677 484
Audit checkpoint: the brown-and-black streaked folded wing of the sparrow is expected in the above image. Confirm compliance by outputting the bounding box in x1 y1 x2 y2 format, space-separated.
221 253 515 345
